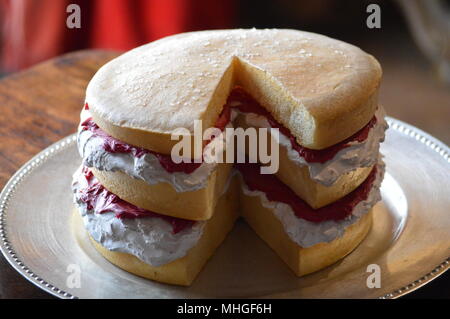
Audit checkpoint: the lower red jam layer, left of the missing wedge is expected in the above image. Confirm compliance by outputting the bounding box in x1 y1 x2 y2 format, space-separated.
80 167 195 234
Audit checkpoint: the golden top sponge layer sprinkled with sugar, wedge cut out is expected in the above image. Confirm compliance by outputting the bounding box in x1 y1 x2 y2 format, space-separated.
86 29 381 154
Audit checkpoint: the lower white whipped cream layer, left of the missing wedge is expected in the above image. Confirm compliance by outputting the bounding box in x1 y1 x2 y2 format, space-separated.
72 167 205 267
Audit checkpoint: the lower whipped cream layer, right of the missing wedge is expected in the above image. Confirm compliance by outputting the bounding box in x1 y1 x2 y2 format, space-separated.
242 157 385 248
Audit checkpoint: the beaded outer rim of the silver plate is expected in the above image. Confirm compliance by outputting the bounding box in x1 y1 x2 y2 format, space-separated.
0 117 450 299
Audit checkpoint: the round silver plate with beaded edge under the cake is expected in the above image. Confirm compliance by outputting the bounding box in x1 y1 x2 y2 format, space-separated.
0 118 450 298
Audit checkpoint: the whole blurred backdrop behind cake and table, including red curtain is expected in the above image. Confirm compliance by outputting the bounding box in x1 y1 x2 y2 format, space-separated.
0 0 450 144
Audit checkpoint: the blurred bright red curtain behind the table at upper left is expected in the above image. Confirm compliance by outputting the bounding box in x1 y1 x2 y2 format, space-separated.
0 0 235 71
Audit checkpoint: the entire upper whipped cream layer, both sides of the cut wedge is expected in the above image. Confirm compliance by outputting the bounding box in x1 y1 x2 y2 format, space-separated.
77 106 388 192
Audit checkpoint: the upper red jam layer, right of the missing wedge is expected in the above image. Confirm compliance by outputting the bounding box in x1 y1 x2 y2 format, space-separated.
224 87 377 163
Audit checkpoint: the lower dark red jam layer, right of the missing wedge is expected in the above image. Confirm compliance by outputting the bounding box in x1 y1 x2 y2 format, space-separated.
235 163 377 223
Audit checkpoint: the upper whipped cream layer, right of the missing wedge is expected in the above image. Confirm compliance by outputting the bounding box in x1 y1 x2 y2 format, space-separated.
241 106 388 186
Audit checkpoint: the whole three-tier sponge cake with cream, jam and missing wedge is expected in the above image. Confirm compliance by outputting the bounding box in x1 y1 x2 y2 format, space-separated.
73 29 387 285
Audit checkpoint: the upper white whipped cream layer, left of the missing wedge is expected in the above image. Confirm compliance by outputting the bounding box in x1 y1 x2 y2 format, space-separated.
77 109 235 192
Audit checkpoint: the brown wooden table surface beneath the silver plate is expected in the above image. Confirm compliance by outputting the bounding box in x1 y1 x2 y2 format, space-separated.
0 50 449 298
